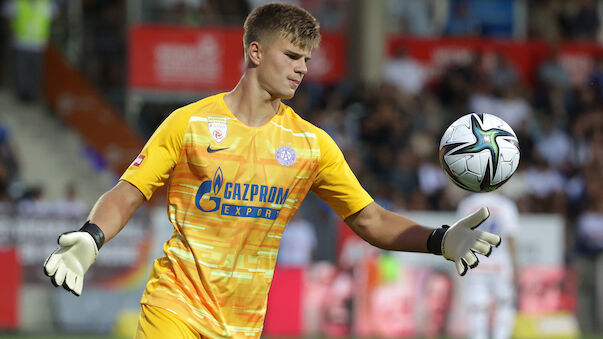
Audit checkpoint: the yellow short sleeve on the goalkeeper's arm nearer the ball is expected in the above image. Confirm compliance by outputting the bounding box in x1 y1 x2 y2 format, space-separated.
311 128 373 219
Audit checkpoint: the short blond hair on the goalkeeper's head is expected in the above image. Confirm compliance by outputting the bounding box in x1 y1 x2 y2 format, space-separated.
243 2 320 61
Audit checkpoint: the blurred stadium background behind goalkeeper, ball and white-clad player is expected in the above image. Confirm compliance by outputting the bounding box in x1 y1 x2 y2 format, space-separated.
0 0 603 338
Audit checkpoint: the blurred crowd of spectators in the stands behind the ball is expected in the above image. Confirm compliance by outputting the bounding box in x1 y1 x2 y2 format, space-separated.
290 41 603 250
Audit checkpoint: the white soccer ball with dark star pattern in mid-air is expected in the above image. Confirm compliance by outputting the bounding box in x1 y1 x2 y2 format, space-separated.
440 113 519 192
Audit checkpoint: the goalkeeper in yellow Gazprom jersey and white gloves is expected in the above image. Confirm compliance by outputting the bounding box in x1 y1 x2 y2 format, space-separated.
44 4 500 338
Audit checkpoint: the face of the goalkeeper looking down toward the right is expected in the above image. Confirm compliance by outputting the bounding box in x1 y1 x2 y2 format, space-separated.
258 36 312 99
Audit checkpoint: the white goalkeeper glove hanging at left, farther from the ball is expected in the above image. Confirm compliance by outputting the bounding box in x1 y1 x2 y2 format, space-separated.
44 222 105 296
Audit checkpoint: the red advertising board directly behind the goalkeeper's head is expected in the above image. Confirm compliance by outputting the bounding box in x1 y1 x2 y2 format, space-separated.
129 25 347 91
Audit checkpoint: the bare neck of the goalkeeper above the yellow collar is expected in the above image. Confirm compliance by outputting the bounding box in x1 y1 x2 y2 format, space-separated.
224 72 281 127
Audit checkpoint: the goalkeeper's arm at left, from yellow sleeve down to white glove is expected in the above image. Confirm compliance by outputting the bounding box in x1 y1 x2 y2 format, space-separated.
44 105 191 295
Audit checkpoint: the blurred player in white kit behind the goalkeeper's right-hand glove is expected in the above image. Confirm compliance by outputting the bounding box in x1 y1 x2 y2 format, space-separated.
458 193 519 339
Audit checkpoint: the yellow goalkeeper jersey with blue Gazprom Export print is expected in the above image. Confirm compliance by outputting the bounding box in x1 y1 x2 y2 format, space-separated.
121 93 373 338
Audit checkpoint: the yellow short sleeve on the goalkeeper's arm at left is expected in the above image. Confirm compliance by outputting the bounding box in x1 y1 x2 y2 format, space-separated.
120 109 191 200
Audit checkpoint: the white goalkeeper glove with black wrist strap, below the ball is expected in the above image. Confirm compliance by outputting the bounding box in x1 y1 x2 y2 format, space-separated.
427 207 501 276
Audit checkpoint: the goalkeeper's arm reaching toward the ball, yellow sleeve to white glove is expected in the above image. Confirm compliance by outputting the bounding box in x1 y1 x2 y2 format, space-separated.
312 128 500 275
